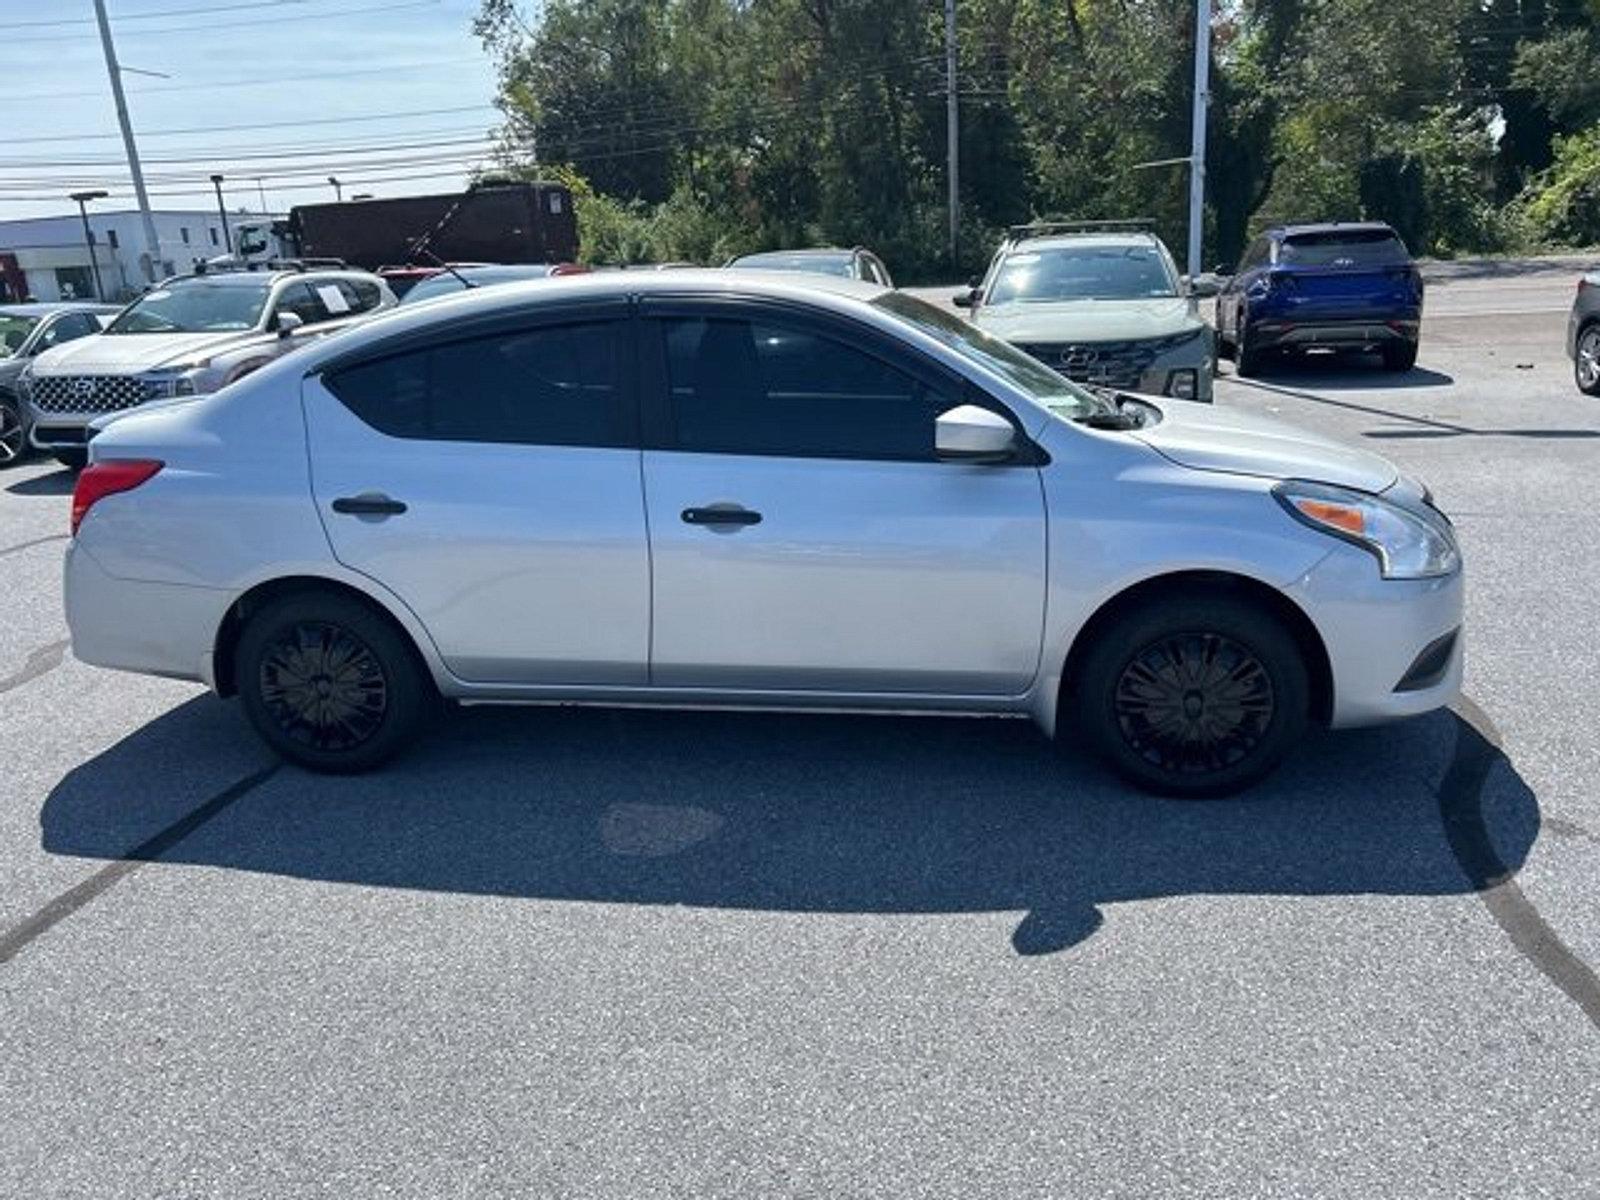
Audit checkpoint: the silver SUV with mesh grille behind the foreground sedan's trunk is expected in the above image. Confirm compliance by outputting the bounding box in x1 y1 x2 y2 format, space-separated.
18 264 397 467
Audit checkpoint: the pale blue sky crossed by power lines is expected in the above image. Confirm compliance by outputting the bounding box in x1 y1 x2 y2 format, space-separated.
0 0 498 219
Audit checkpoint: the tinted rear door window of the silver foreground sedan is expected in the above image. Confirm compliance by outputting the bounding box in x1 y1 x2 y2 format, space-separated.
326 322 630 446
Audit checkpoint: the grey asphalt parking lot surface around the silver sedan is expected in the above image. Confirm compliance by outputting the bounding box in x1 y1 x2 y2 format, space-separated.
0 262 1600 1200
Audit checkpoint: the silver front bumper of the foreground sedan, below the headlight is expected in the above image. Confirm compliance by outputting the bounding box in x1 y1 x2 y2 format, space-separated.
1286 546 1466 728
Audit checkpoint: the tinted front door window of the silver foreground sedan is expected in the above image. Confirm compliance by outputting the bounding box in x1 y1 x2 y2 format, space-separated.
664 318 957 461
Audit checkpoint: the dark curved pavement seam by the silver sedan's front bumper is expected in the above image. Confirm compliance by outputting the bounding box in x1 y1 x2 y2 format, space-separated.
1438 696 1600 1027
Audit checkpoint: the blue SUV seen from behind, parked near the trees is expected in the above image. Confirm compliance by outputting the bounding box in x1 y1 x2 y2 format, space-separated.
1216 221 1422 376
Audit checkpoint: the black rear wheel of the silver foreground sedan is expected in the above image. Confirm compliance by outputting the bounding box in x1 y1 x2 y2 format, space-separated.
235 592 434 774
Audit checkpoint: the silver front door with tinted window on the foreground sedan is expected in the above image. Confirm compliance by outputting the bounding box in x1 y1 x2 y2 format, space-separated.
643 301 1045 696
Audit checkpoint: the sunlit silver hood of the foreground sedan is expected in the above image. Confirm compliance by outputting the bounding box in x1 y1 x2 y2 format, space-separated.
1133 397 1400 493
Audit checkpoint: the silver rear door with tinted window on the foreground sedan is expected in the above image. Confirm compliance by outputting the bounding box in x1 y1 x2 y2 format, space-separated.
302 304 650 685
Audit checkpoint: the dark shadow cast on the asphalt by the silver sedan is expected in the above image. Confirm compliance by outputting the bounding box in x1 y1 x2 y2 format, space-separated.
40 698 1539 954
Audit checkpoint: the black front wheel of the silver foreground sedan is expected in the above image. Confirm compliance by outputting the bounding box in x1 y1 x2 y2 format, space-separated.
1067 595 1310 798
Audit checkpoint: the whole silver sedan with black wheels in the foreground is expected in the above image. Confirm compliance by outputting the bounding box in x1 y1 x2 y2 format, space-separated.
66 270 1462 794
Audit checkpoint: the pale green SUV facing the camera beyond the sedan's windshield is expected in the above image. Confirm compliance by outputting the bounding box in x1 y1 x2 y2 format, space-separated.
955 221 1216 403
